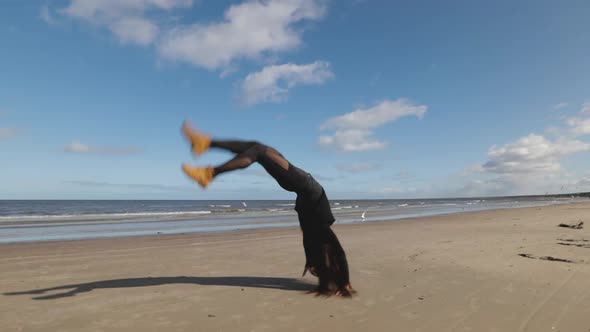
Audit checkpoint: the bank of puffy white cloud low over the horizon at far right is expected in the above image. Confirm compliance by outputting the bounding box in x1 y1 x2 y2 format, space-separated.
474 103 590 195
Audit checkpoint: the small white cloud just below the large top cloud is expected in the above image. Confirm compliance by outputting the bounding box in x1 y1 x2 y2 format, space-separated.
240 61 334 105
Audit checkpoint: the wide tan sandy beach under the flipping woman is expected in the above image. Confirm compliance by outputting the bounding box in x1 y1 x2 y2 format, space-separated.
0 203 590 332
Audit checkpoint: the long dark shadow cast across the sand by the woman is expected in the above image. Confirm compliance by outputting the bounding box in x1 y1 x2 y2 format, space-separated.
4 276 315 300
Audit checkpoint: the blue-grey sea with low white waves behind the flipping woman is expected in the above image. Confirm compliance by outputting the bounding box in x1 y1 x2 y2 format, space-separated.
0 195 588 243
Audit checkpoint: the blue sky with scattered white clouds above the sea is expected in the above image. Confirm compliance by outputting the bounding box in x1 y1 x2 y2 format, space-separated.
0 0 590 199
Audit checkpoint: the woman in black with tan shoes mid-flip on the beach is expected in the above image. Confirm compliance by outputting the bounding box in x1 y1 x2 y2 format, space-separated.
182 122 354 296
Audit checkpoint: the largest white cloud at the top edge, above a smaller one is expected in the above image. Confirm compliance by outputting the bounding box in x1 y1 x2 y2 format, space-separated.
158 0 325 69
